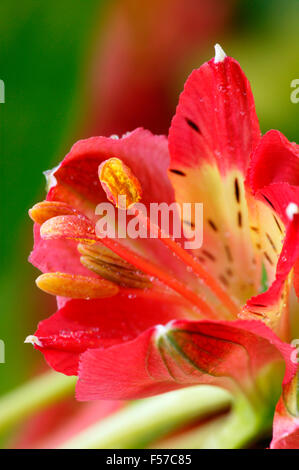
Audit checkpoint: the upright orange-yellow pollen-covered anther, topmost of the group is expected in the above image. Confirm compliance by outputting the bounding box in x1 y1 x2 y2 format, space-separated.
98 158 142 209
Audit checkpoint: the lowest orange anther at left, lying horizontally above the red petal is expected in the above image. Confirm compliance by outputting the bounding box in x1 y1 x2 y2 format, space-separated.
35 272 119 299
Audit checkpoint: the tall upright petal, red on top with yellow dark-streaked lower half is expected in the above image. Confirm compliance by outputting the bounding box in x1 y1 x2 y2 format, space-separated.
169 53 260 303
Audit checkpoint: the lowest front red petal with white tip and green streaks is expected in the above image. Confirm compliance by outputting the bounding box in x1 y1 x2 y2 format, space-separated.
77 321 295 400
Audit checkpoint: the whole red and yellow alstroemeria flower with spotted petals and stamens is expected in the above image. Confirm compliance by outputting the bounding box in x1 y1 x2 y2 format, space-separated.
28 46 299 448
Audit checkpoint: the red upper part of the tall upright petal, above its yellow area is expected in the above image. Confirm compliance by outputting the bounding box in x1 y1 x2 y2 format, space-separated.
169 57 260 172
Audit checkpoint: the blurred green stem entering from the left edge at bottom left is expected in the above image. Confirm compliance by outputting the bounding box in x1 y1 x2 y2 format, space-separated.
0 371 77 432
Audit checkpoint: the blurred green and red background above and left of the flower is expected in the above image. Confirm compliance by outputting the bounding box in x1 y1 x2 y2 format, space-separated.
0 0 299 444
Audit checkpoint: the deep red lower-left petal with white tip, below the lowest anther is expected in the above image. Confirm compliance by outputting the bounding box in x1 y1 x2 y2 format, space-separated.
31 291 190 375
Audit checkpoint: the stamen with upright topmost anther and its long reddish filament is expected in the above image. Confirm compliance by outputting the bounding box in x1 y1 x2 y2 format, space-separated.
99 159 239 315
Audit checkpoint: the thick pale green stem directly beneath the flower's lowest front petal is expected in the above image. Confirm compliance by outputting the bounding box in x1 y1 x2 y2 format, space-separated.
61 385 232 449
